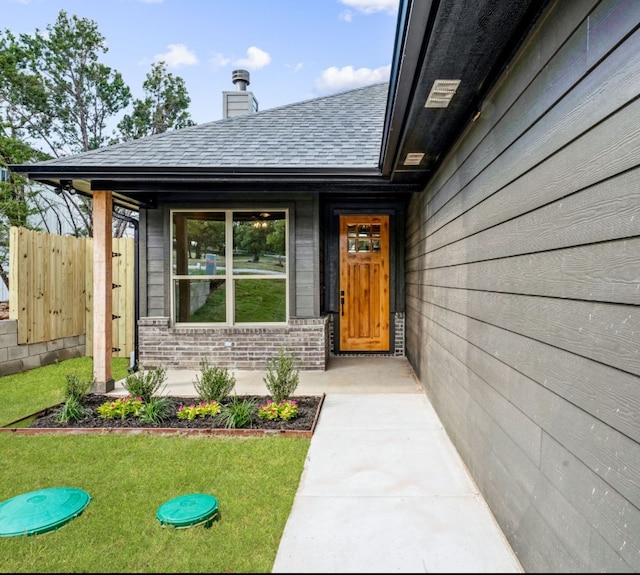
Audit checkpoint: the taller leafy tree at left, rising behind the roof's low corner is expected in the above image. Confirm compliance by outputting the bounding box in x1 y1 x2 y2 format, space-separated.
0 10 131 241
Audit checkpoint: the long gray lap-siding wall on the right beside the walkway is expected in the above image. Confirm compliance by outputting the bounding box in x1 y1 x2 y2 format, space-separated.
406 1 640 572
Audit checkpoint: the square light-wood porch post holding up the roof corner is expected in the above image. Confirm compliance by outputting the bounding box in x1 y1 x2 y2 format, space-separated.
93 192 115 393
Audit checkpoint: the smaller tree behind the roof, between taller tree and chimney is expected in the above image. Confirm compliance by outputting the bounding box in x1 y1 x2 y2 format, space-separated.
118 62 195 141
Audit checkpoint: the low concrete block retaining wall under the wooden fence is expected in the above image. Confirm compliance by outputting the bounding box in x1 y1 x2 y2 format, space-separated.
0 319 86 377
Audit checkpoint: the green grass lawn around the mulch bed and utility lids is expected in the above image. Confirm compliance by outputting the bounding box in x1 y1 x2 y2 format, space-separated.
0 358 310 573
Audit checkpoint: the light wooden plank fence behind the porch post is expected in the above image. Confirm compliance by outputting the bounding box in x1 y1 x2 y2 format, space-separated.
9 227 135 357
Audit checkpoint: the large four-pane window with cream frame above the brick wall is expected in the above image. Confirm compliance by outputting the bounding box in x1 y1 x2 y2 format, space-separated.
171 210 288 325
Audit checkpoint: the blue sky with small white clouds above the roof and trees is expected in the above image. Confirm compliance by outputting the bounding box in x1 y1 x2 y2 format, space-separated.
0 0 398 124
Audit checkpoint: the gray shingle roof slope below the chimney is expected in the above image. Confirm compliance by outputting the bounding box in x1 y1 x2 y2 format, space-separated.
37 83 389 168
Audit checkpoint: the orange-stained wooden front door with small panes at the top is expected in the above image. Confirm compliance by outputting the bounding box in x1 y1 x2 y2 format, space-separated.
338 215 389 351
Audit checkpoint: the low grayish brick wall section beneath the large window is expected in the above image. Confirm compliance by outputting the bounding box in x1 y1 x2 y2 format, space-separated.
138 317 329 371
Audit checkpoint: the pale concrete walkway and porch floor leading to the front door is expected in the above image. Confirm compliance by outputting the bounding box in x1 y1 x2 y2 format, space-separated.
111 357 523 573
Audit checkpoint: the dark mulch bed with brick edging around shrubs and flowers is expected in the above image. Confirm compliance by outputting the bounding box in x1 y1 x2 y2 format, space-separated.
5 394 324 437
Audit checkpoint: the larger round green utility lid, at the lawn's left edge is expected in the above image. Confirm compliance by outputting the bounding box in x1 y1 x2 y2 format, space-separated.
0 487 91 537
